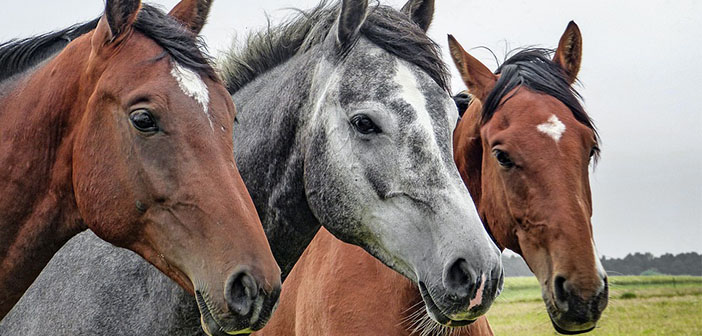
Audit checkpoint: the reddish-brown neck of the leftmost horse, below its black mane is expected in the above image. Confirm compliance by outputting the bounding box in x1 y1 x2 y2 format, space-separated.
0 34 89 319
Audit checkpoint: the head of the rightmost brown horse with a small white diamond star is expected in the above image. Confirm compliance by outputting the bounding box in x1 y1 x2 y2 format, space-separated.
449 22 608 333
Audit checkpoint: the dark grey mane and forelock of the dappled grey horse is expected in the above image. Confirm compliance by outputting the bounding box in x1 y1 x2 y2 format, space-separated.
220 1 450 93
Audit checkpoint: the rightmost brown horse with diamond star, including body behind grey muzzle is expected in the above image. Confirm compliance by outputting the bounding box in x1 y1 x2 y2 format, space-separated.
258 22 608 336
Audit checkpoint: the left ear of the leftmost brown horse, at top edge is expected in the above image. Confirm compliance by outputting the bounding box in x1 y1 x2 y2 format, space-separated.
93 0 141 45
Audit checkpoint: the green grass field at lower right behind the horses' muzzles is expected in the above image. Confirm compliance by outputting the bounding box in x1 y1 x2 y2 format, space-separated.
488 276 702 336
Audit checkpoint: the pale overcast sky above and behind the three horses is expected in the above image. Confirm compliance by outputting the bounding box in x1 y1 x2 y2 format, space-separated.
0 0 702 257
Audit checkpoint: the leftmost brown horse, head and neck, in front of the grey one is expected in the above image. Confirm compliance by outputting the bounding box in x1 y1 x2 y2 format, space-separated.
0 0 281 334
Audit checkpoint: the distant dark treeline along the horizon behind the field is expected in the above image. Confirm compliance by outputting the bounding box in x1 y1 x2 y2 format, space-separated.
502 252 702 276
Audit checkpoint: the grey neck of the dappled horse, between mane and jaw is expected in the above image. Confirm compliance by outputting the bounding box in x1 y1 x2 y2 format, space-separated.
232 51 321 279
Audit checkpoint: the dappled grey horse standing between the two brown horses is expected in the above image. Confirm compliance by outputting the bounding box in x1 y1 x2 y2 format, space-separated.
0 0 503 335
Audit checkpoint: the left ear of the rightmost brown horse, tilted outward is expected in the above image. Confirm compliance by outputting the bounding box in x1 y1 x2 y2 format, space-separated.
448 35 497 102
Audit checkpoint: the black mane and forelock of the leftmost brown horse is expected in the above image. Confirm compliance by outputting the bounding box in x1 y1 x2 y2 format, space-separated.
0 4 216 81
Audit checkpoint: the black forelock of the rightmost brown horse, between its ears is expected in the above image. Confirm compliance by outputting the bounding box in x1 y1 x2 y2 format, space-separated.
481 48 600 161
